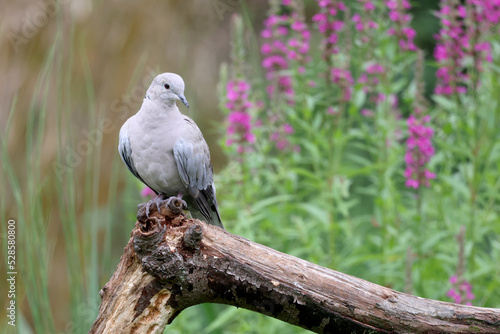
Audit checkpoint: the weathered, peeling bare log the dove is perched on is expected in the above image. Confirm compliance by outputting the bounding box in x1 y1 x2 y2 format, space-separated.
90 198 500 333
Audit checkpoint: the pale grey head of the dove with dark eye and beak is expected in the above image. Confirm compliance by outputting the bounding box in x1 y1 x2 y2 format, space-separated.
146 73 189 108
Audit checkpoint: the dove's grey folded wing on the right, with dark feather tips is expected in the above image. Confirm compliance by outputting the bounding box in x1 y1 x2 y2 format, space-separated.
174 116 222 226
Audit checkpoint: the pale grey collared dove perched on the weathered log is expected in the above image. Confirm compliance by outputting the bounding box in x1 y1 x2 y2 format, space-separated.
118 73 224 228
